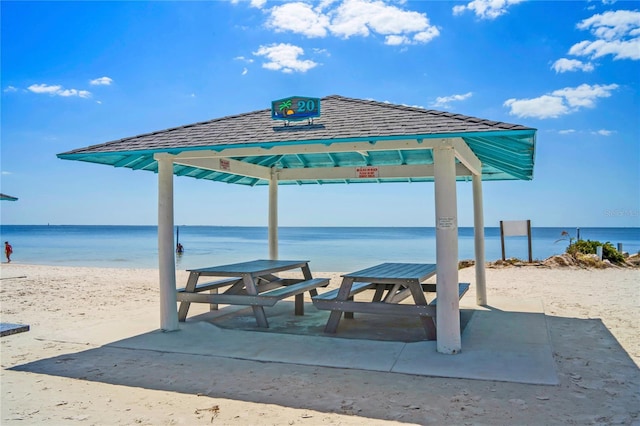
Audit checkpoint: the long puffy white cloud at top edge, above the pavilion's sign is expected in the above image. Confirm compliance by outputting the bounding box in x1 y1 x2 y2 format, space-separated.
267 0 440 45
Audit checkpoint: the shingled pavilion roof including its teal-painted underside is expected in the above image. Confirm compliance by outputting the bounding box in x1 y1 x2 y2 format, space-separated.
58 95 536 185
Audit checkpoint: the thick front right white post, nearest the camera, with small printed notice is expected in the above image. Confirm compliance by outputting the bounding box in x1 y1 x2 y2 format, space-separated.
433 146 462 354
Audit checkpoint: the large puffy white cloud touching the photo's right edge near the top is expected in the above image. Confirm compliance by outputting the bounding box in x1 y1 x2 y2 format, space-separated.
569 10 640 60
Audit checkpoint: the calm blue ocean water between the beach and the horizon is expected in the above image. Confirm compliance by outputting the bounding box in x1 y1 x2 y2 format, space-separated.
0 225 640 271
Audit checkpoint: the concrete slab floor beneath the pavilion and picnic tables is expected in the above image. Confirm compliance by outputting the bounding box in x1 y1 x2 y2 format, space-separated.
107 296 559 385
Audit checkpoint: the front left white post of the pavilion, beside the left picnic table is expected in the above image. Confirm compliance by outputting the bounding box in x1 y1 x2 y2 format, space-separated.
155 154 178 331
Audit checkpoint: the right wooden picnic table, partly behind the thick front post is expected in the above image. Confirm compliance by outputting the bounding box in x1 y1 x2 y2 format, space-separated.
312 263 469 340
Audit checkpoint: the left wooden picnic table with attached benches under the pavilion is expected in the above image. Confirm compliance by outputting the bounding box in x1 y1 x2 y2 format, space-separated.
177 260 329 328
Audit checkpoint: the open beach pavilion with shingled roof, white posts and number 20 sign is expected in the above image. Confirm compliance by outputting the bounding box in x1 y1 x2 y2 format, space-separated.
58 95 536 354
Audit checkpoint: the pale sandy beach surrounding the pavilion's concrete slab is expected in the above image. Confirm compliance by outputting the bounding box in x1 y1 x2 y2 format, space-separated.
0 263 640 425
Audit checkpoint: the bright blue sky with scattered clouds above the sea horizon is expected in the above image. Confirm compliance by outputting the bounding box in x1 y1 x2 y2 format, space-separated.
0 0 640 227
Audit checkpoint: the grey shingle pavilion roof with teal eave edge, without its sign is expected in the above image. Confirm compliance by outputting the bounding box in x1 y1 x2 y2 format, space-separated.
58 95 535 184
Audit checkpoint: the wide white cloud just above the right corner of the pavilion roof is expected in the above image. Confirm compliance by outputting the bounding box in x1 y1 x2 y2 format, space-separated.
504 84 618 119
